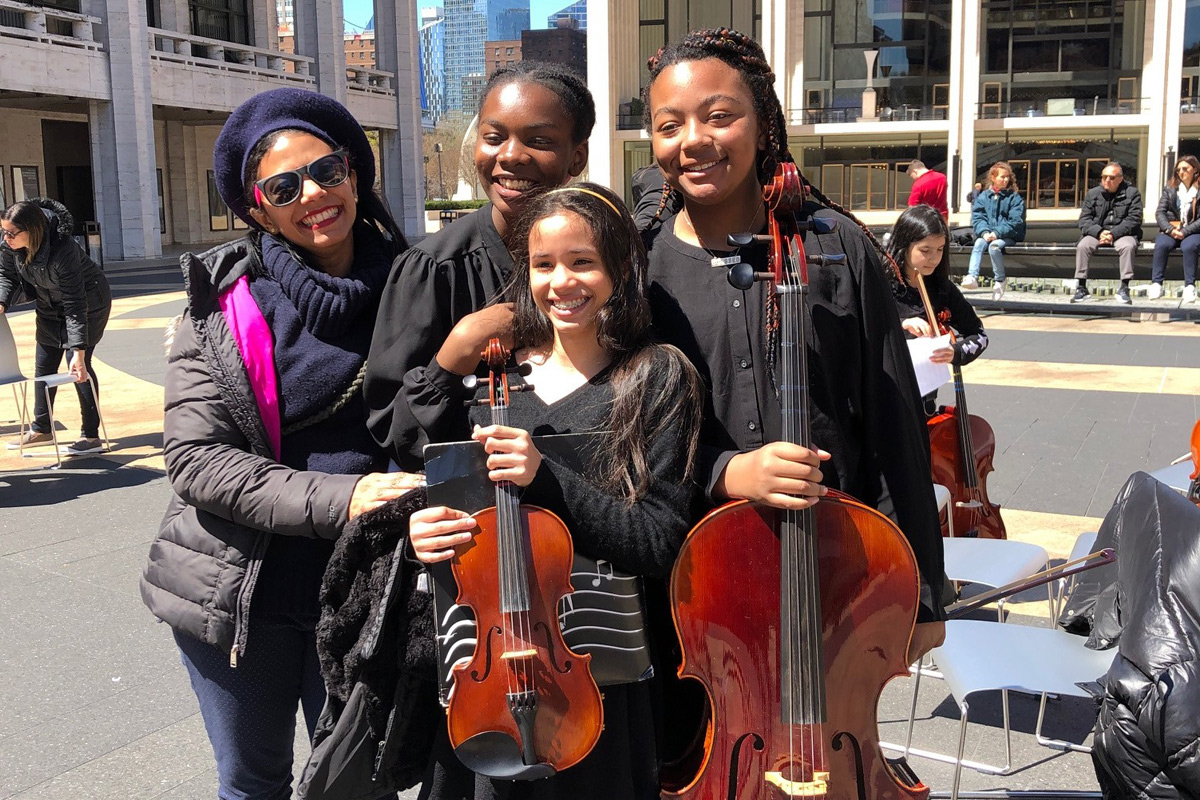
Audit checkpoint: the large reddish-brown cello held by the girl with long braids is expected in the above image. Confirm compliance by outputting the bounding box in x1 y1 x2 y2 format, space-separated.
664 163 929 800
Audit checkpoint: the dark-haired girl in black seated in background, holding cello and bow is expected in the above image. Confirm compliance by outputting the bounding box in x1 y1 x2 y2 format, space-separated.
888 205 988 413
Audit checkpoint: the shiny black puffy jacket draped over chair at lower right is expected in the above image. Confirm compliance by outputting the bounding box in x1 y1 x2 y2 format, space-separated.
1092 473 1200 800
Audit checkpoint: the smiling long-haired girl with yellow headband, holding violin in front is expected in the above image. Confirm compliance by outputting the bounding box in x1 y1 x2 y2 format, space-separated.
409 184 701 800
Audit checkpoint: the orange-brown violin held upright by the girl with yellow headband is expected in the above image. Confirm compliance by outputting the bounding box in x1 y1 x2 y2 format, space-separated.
446 339 604 780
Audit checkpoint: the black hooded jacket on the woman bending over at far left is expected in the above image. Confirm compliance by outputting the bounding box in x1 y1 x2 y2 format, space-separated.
0 197 113 350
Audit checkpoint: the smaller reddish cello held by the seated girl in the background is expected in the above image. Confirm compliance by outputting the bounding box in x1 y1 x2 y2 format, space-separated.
917 272 1008 539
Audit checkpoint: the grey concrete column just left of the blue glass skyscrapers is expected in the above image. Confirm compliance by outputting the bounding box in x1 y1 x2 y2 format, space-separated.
379 0 425 236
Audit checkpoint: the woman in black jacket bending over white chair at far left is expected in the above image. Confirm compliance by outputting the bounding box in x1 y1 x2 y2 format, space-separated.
0 197 113 455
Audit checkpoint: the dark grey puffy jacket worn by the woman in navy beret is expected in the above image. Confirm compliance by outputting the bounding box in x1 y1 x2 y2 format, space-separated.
142 237 360 663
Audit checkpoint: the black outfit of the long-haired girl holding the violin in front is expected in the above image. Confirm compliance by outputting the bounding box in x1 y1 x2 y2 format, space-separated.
419 351 692 800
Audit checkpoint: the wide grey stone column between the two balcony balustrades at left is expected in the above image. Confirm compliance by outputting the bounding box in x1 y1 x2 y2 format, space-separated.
88 0 162 259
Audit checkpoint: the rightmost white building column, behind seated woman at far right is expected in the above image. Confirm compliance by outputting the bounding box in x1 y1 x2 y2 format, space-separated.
1141 0 1184 195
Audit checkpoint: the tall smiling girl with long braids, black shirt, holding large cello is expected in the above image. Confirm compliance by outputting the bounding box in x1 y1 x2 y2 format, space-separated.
644 29 943 623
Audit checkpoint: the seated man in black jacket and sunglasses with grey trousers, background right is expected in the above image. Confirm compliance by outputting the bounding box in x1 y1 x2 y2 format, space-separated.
1070 161 1141 305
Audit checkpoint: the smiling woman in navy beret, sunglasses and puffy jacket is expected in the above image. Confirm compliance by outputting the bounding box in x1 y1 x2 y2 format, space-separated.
142 89 416 799
